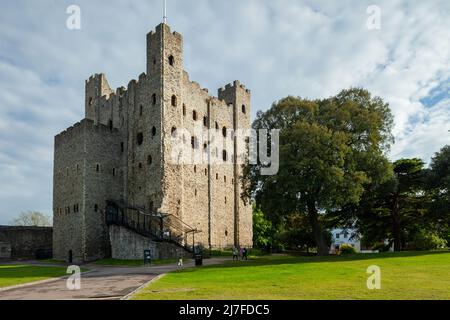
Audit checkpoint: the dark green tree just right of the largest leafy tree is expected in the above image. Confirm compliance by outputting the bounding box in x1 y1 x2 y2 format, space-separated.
354 159 430 251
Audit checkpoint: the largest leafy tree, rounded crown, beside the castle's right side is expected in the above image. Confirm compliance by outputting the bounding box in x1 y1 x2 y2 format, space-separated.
244 89 393 255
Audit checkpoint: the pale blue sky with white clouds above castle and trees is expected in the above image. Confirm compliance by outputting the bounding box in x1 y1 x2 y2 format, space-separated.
0 0 450 224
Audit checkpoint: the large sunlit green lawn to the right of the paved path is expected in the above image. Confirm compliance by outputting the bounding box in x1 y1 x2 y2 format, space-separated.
133 252 450 300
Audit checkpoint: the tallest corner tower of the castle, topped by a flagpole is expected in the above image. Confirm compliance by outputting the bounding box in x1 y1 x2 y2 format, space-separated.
147 23 185 238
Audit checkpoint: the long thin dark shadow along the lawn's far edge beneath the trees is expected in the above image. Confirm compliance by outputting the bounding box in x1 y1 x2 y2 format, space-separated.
175 251 450 272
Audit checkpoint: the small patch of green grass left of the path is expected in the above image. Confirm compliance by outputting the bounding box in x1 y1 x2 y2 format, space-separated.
0 265 67 288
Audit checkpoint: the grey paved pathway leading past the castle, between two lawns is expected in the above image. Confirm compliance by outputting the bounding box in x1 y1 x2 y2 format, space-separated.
0 258 224 300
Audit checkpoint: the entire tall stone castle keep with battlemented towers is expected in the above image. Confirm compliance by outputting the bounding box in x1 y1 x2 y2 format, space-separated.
53 23 252 261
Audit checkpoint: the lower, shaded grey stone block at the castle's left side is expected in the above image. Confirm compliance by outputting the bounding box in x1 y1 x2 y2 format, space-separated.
53 119 125 261
